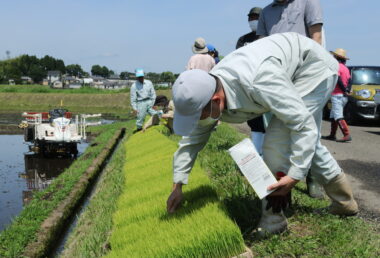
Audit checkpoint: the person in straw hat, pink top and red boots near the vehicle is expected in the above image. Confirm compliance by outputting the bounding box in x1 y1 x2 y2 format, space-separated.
322 48 352 142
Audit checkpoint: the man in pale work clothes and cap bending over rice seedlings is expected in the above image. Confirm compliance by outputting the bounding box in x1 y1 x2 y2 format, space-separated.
167 32 358 236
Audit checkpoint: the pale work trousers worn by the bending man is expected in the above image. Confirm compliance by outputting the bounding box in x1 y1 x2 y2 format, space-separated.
263 76 341 185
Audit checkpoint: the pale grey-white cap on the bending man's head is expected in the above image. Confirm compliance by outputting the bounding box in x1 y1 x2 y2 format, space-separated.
172 69 216 136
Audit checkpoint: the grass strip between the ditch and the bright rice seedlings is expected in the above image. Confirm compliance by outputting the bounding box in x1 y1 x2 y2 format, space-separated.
61 121 134 257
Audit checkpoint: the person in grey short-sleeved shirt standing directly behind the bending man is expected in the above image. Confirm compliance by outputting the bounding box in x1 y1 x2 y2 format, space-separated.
256 0 325 199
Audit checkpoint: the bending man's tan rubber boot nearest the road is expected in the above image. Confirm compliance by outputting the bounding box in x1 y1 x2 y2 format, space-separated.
324 172 359 216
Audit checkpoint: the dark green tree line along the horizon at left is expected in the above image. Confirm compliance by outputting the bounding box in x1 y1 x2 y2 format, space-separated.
0 55 178 84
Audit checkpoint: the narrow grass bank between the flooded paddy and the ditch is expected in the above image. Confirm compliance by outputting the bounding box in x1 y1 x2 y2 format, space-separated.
0 124 122 257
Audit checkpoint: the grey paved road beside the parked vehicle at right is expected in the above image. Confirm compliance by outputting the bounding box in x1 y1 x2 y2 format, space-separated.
236 121 380 222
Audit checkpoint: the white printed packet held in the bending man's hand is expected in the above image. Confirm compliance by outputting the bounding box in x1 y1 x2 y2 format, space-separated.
228 138 277 199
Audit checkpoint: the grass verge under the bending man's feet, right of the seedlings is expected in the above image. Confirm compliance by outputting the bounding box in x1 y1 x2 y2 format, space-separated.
196 123 380 257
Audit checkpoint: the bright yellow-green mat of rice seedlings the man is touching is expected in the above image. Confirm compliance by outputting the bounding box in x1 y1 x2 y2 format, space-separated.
108 129 244 257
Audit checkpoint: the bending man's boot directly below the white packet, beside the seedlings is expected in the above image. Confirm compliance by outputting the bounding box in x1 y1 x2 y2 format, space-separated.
255 198 288 237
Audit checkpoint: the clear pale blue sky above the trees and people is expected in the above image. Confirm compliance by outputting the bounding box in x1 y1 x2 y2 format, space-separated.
0 0 380 73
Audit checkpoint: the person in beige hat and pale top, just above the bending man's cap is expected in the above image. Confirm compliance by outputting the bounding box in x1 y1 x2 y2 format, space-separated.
186 38 215 72
